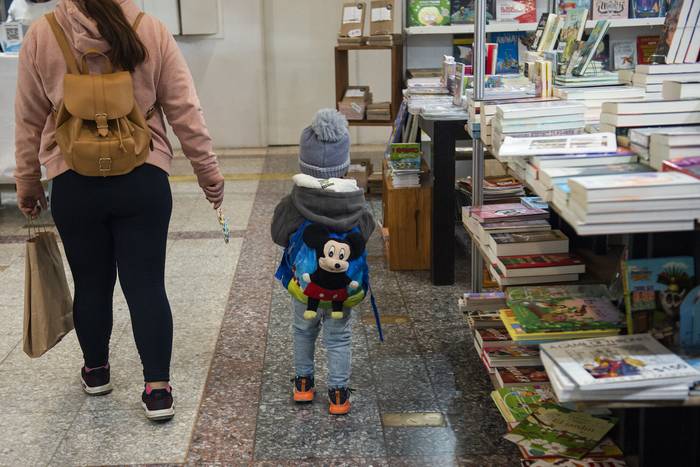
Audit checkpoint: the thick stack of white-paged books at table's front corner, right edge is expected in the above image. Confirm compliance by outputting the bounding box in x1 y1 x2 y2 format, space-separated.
567 171 700 235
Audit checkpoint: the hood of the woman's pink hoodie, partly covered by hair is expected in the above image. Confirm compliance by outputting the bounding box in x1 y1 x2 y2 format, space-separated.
55 0 140 53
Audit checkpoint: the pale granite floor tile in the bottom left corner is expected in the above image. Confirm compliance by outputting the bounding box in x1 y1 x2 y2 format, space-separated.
0 411 77 466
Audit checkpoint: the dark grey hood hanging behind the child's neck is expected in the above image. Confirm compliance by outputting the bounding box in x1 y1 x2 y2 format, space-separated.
292 186 366 232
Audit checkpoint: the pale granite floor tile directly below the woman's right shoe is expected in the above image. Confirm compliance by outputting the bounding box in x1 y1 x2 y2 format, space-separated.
50 407 196 466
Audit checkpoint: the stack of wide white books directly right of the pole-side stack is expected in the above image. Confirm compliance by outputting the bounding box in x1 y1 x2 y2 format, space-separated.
600 99 700 149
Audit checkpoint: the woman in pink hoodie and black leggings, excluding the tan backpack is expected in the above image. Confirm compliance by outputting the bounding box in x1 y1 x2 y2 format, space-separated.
15 0 224 420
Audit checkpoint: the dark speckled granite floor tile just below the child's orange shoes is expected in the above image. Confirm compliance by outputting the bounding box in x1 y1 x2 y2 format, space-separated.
255 398 385 460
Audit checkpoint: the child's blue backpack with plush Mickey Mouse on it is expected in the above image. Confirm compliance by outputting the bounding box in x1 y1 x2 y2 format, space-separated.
275 221 384 340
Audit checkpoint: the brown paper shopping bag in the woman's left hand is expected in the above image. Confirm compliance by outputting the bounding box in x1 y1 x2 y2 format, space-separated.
24 232 73 358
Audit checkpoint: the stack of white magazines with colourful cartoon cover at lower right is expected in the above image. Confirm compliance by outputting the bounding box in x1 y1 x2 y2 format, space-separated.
540 334 700 402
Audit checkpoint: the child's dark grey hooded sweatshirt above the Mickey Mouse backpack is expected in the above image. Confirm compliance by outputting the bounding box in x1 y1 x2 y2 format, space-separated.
272 185 375 248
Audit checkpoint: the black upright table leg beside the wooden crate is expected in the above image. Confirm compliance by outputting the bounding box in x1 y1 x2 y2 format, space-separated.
431 122 456 285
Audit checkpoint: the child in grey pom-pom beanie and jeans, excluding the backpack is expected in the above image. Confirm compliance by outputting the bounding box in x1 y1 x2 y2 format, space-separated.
272 109 375 415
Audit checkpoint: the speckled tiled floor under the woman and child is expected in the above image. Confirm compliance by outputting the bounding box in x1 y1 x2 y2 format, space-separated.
0 148 518 466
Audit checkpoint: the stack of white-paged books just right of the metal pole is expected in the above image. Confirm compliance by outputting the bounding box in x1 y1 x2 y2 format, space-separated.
491 101 586 157
